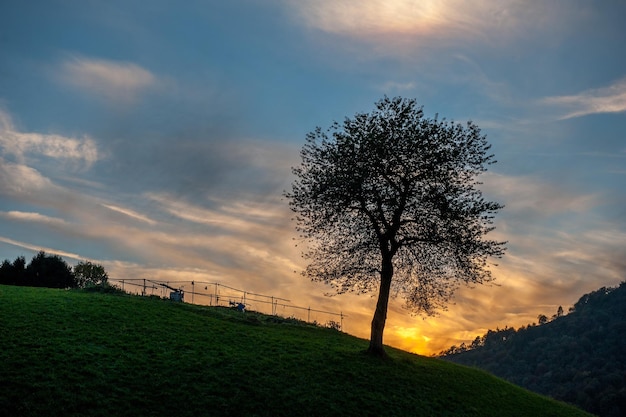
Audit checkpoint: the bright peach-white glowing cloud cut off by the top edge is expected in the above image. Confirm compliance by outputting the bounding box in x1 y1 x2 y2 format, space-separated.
285 0 564 45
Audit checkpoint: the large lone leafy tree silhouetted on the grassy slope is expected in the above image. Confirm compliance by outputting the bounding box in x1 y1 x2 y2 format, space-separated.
285 97 504 356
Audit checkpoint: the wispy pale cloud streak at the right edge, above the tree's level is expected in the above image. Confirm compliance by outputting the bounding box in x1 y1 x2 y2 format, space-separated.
541 78 626 120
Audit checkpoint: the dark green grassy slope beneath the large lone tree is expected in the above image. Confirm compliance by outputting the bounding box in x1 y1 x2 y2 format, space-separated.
0 286 588 417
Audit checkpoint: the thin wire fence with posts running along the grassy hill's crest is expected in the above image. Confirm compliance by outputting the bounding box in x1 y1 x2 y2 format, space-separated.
109 278 347 330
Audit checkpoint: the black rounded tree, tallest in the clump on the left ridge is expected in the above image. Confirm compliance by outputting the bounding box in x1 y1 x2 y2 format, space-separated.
26 251 76 288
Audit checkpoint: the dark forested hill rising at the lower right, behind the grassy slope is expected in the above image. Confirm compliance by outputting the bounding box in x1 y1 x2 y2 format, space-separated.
442 281 626 417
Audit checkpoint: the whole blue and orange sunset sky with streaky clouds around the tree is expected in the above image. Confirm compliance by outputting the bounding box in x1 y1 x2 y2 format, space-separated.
0 0 626 354
